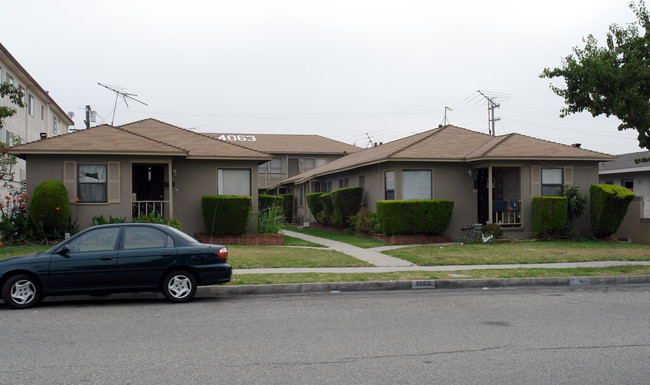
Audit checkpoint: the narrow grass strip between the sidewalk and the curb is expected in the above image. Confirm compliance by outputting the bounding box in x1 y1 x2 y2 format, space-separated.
228 266 650 285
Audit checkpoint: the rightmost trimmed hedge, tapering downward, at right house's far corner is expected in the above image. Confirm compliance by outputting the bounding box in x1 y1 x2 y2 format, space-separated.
589 184 635 238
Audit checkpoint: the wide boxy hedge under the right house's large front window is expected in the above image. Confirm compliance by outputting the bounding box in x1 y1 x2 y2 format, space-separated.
377 199 454 235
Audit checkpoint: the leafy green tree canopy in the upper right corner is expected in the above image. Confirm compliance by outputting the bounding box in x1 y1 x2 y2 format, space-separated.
539 0 650 149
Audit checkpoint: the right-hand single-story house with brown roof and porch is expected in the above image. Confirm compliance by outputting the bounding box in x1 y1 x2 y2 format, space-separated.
283 125 615 240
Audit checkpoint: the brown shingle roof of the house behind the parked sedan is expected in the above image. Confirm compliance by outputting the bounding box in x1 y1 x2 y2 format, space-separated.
11 119 270 160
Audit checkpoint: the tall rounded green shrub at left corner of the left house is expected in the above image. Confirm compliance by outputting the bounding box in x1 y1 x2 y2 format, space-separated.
29 180 70 232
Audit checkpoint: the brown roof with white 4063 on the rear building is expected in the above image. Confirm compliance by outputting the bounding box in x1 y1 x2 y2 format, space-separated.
205 133 361 155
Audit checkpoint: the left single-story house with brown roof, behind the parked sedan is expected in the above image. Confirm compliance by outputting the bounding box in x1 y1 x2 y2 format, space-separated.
12 119 271 234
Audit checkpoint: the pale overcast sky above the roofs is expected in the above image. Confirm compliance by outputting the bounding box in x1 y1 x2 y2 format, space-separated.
0 0 641 154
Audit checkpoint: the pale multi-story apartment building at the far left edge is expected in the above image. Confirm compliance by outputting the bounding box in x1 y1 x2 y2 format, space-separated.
0 44 74 189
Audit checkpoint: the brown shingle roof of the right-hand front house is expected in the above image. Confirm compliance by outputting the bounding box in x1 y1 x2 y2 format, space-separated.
283 126 616 183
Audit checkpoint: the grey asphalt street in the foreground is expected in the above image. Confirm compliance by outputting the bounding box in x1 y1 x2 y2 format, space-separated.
0 284 650 384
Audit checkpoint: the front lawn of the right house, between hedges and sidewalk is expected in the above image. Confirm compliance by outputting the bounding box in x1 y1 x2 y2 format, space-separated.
384 241 650 266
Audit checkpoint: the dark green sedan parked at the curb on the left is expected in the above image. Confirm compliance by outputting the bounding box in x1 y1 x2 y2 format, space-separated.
0 223 232 309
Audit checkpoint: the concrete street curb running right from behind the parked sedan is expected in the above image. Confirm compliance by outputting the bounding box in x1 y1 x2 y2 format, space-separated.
197 275 650 297
